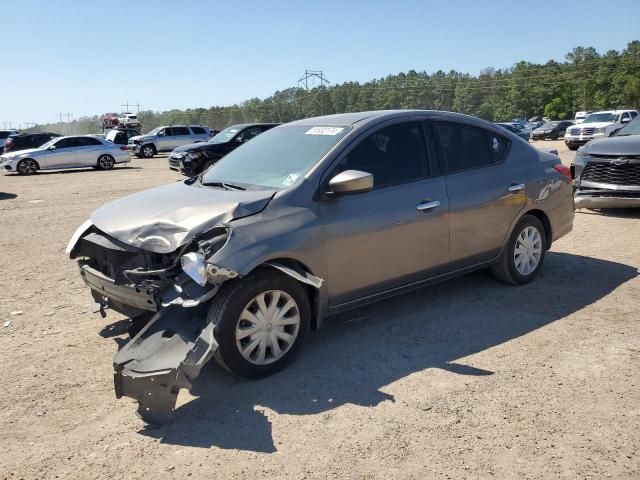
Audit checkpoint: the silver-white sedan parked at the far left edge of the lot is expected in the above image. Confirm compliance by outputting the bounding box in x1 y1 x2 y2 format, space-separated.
0 135 130 175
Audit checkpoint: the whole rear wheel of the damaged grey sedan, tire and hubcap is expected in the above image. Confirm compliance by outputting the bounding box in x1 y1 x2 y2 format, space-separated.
491 215 547 285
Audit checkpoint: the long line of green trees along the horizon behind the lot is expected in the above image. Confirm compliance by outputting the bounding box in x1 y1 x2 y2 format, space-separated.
32 40 640 135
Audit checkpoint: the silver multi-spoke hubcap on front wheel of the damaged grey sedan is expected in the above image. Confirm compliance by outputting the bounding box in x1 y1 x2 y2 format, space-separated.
236 290 301 365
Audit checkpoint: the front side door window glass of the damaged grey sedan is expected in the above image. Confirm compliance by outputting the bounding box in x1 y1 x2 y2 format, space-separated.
340 122 430 188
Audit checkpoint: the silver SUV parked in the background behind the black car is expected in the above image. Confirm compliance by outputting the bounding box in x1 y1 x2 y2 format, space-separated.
128 125 209 158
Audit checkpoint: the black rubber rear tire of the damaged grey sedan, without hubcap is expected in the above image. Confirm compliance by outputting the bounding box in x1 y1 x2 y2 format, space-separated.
491 215 547 285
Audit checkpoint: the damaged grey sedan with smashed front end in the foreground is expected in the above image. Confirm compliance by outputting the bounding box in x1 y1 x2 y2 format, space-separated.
67 110 574 423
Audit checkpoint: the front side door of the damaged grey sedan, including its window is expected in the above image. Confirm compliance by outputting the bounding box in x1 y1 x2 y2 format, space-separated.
320 120 450 306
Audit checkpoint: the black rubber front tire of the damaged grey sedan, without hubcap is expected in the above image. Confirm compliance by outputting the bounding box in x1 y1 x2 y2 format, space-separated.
207 269 311 379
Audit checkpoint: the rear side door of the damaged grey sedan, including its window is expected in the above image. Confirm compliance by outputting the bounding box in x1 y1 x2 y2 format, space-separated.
435 120 527 269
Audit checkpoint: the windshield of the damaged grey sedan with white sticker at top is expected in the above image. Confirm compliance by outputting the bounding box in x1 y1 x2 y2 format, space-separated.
202 125 350 190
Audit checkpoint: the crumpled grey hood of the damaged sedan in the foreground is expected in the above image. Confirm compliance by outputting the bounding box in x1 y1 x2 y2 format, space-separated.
91 180 275 253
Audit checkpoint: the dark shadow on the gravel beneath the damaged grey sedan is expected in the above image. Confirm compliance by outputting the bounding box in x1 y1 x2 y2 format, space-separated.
140 252 638 453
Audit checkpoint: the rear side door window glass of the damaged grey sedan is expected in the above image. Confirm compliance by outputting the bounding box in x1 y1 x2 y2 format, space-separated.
438 122 509 172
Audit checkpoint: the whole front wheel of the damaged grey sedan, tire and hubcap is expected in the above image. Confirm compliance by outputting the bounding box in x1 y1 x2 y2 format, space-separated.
208 270 311 379
